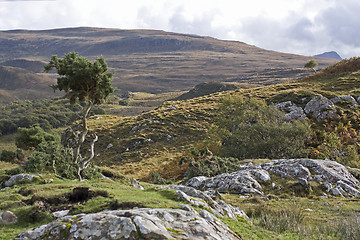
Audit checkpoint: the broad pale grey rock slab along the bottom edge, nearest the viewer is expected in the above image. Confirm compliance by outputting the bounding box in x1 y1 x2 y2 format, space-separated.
16 206 241 240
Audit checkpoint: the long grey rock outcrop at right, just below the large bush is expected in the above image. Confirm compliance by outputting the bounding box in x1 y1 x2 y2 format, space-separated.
185 159 360 196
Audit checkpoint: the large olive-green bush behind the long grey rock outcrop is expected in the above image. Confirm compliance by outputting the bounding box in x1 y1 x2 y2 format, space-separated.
215 96 311 159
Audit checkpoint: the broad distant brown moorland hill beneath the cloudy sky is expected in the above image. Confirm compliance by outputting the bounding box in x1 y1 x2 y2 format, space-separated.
0 28 336 102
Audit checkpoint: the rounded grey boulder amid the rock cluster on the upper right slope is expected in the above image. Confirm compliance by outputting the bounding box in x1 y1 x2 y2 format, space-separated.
304 96 336 122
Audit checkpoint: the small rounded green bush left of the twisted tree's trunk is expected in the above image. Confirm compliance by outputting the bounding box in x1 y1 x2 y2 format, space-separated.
15 124 56 150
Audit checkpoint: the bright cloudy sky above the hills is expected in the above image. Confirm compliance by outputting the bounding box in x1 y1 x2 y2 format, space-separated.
0 0 360 58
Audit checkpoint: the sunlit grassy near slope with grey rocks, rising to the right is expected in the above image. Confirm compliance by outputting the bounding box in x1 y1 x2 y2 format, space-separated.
0 58 360 240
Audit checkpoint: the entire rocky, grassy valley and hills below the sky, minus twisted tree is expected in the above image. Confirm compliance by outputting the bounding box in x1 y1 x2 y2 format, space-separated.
0 28 360 240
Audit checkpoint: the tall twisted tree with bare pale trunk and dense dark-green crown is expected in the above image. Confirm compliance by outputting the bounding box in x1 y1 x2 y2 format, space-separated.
45 52 114 180
